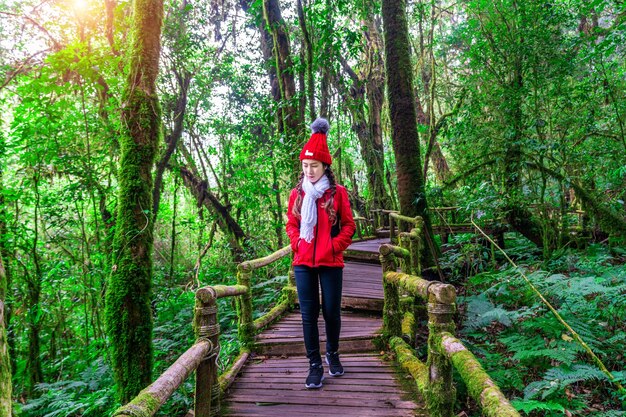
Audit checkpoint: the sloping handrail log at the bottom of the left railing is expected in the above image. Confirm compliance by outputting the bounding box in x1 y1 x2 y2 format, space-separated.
112 340 213 417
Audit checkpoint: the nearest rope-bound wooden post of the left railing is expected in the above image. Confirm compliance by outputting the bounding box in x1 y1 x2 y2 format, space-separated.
194 288 220 417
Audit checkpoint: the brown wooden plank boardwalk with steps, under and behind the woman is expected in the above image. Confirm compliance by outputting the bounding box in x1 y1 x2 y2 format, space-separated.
221 239 427 417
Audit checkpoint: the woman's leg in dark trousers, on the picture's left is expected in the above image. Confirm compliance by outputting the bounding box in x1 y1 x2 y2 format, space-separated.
294 265 322 365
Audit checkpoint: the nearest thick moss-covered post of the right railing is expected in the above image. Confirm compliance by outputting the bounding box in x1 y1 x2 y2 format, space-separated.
426 281 456 417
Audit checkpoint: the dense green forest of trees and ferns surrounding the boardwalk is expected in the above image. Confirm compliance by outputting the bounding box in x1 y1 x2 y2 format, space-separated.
0 0 626 417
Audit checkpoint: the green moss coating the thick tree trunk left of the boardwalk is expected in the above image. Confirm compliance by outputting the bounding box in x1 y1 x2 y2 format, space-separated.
105 62 162 403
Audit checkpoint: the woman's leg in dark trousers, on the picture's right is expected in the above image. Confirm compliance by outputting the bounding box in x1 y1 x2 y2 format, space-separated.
319 266 343 352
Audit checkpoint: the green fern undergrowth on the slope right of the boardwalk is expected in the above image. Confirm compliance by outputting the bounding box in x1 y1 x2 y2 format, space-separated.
443 237 626 417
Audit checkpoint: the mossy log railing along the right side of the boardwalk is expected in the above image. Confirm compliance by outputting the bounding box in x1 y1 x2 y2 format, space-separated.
380 213 519 417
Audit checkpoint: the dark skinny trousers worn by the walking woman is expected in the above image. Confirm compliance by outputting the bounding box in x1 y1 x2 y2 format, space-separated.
294 265 343 364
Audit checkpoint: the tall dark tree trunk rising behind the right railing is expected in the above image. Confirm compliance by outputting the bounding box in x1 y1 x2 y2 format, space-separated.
382 0 433 267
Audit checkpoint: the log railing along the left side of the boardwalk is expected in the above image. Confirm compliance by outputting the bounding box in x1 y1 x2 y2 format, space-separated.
113 246 296 417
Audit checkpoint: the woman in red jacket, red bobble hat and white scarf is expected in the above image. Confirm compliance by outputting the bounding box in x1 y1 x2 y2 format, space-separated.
287 119 356 388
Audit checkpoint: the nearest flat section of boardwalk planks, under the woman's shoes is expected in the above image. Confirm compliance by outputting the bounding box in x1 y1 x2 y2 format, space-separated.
221 353 425 417
